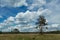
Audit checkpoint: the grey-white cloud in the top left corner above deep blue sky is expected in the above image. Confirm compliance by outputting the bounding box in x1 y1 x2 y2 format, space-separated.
0 0 28 7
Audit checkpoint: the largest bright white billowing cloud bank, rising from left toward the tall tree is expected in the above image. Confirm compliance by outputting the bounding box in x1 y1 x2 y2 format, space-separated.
0 9 51 32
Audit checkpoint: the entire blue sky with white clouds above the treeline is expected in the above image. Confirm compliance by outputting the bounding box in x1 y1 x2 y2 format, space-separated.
0 0 60 32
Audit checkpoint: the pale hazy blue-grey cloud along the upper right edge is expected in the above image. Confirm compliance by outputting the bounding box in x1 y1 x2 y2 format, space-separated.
46 0 60 24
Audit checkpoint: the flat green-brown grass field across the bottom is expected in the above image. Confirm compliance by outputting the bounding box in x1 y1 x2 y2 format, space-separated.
0 34 60 40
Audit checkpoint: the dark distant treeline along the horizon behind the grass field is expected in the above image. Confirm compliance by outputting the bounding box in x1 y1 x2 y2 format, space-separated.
0 31 60 34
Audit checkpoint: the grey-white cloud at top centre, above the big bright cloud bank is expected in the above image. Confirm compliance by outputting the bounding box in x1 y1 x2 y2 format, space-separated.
28 0 46 10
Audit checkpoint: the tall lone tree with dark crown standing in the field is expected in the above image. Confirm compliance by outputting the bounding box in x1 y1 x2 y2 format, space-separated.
37 15 47 34
